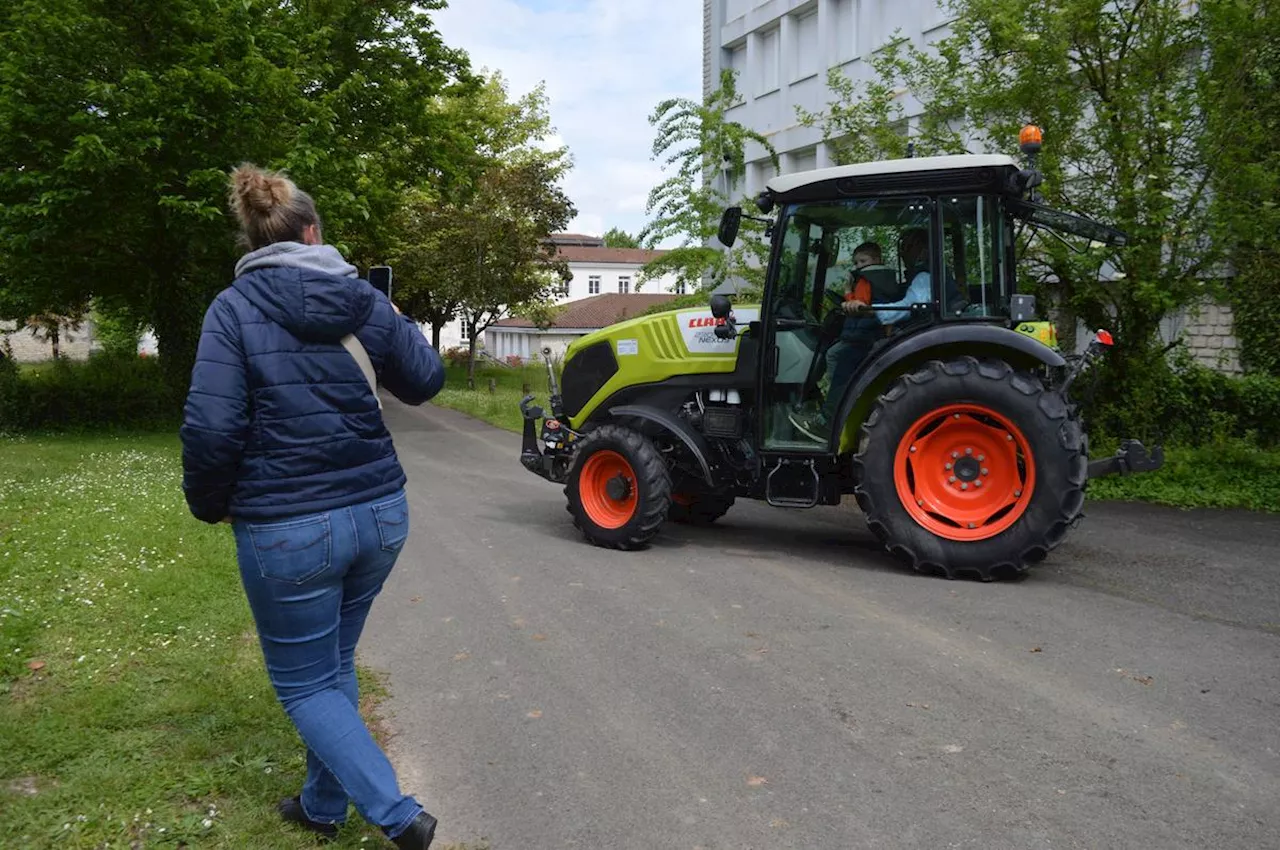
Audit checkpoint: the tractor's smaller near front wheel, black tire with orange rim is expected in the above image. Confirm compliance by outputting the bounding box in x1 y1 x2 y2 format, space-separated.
564 425 671 549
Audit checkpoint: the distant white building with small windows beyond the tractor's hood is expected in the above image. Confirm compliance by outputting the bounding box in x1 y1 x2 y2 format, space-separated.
424 233 682 356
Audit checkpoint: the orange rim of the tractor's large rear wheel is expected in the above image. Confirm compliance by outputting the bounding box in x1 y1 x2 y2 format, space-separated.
893 405 1036 541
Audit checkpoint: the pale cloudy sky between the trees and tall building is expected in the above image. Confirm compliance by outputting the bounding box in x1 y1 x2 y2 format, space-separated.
434 0 703 240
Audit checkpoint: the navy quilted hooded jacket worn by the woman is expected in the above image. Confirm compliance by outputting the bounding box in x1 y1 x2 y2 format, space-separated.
182 242 444 522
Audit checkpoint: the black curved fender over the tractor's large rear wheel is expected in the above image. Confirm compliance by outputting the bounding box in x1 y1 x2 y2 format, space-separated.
829 321 1066 453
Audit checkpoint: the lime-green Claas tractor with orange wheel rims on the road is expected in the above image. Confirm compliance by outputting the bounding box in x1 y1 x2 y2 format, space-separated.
521 138 1162 580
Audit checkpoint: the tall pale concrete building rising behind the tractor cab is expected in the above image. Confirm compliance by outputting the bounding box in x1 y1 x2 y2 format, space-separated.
703 0 950 196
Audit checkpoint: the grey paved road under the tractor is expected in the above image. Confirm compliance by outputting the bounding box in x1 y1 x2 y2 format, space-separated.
362 401 1280 850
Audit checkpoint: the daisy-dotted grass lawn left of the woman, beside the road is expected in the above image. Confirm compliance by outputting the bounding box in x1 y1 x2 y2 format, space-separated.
0 435 478 850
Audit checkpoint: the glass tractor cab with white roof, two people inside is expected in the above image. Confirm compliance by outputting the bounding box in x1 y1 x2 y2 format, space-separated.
713 156 1124 453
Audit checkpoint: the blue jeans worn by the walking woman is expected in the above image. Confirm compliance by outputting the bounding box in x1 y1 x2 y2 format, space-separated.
233 490 422 837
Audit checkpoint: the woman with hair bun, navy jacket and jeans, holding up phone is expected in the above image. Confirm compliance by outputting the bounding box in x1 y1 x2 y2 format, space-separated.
182 165 444 850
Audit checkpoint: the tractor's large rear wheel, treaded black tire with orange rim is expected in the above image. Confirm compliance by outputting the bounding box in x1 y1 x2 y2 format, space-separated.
854 357 1088 581
